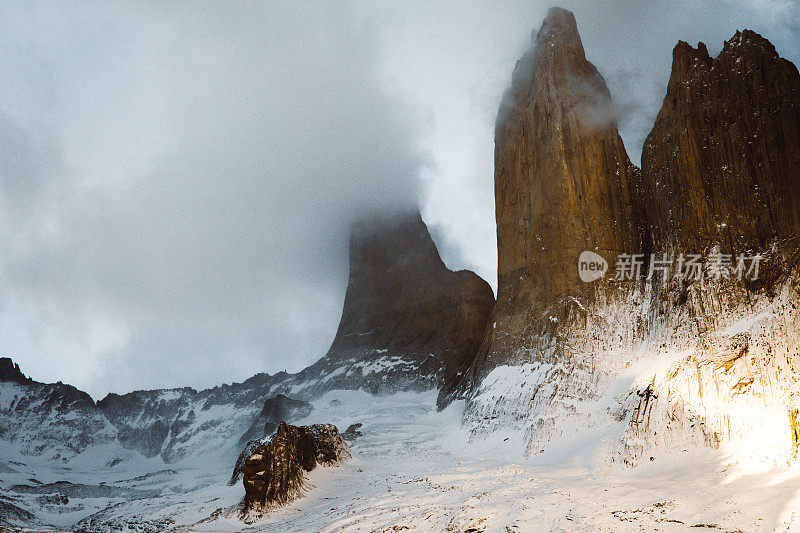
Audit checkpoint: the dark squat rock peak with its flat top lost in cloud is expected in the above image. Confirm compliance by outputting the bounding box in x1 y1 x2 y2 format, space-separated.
298 213 494 402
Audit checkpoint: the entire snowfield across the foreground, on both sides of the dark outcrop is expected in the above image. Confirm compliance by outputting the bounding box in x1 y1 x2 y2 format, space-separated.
1 391 800 532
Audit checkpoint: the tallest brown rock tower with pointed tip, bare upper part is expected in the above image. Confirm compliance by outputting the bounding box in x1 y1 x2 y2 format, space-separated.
466 8 648 382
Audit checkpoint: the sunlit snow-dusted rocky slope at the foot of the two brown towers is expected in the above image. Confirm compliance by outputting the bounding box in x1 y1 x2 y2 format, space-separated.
465 277 800 465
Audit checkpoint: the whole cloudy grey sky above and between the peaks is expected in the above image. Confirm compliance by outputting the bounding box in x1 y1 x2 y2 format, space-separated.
0 0 800 398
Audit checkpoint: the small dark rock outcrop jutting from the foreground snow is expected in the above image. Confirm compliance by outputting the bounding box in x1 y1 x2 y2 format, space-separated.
242 422 350 518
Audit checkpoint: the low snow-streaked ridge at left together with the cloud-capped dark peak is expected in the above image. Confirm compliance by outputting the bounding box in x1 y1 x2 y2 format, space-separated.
0 212 494 468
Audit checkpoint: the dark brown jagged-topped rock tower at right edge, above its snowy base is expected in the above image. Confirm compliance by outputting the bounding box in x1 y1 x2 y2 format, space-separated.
642 30 800 272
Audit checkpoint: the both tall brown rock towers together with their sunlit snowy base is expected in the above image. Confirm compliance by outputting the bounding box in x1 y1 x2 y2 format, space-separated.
459 8 800 460
